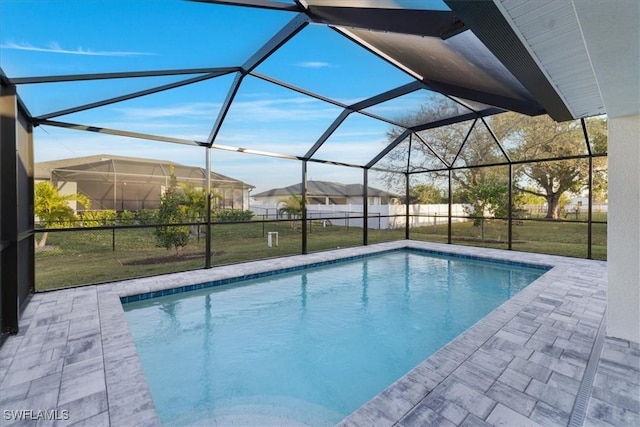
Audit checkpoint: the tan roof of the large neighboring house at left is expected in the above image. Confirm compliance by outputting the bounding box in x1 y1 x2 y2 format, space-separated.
34 154 254 188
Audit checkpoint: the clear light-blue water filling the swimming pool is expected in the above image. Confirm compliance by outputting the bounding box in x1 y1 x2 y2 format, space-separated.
124 251 545 426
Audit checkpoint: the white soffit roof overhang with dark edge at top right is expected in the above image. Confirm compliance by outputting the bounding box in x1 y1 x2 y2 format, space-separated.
445 0 640 121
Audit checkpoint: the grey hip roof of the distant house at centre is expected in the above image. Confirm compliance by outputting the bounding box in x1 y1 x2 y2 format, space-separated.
252 181 399 197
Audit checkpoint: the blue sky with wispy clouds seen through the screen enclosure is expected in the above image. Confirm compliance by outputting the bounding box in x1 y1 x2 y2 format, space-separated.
0 0 448 192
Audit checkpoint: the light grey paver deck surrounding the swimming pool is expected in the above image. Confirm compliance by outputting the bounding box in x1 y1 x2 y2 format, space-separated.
0 241 640 427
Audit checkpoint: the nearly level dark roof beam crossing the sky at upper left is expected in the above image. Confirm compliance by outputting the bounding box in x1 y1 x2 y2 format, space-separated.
10 67 240 85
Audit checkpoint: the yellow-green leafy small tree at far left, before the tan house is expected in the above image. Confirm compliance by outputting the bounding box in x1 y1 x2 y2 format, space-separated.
33 181 91 248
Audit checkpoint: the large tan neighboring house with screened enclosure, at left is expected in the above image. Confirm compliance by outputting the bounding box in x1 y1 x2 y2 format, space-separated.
34 154 254 211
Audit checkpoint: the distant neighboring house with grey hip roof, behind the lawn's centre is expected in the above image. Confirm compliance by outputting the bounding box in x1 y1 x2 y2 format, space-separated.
251 181 400 206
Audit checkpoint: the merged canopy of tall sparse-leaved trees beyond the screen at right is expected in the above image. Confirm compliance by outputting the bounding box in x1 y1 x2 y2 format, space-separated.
384 97 607 218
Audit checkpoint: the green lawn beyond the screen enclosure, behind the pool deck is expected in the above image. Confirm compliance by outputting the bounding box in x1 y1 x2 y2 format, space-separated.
36 220 606 290
